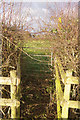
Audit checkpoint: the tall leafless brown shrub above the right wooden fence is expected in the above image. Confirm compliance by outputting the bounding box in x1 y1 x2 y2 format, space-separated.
45 3 78 71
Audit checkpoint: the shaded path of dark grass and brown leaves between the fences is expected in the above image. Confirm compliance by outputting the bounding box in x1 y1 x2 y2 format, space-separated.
21 51 55 118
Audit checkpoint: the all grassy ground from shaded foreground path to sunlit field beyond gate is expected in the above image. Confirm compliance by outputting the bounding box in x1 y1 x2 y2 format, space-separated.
21 40 55 118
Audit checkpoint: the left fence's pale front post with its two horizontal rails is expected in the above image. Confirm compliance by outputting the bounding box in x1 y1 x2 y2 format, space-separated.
0 70 20 118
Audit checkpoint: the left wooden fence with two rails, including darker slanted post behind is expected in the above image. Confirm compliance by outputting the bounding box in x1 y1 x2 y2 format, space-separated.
0 60 20 119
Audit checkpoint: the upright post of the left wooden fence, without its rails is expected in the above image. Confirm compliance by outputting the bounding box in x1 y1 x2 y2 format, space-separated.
10 70 17 118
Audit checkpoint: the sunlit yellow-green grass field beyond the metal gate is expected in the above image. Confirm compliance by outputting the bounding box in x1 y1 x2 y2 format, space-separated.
24 40 51 55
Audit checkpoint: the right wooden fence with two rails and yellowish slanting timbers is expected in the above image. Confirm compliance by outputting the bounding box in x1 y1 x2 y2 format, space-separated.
54 57 80 119
